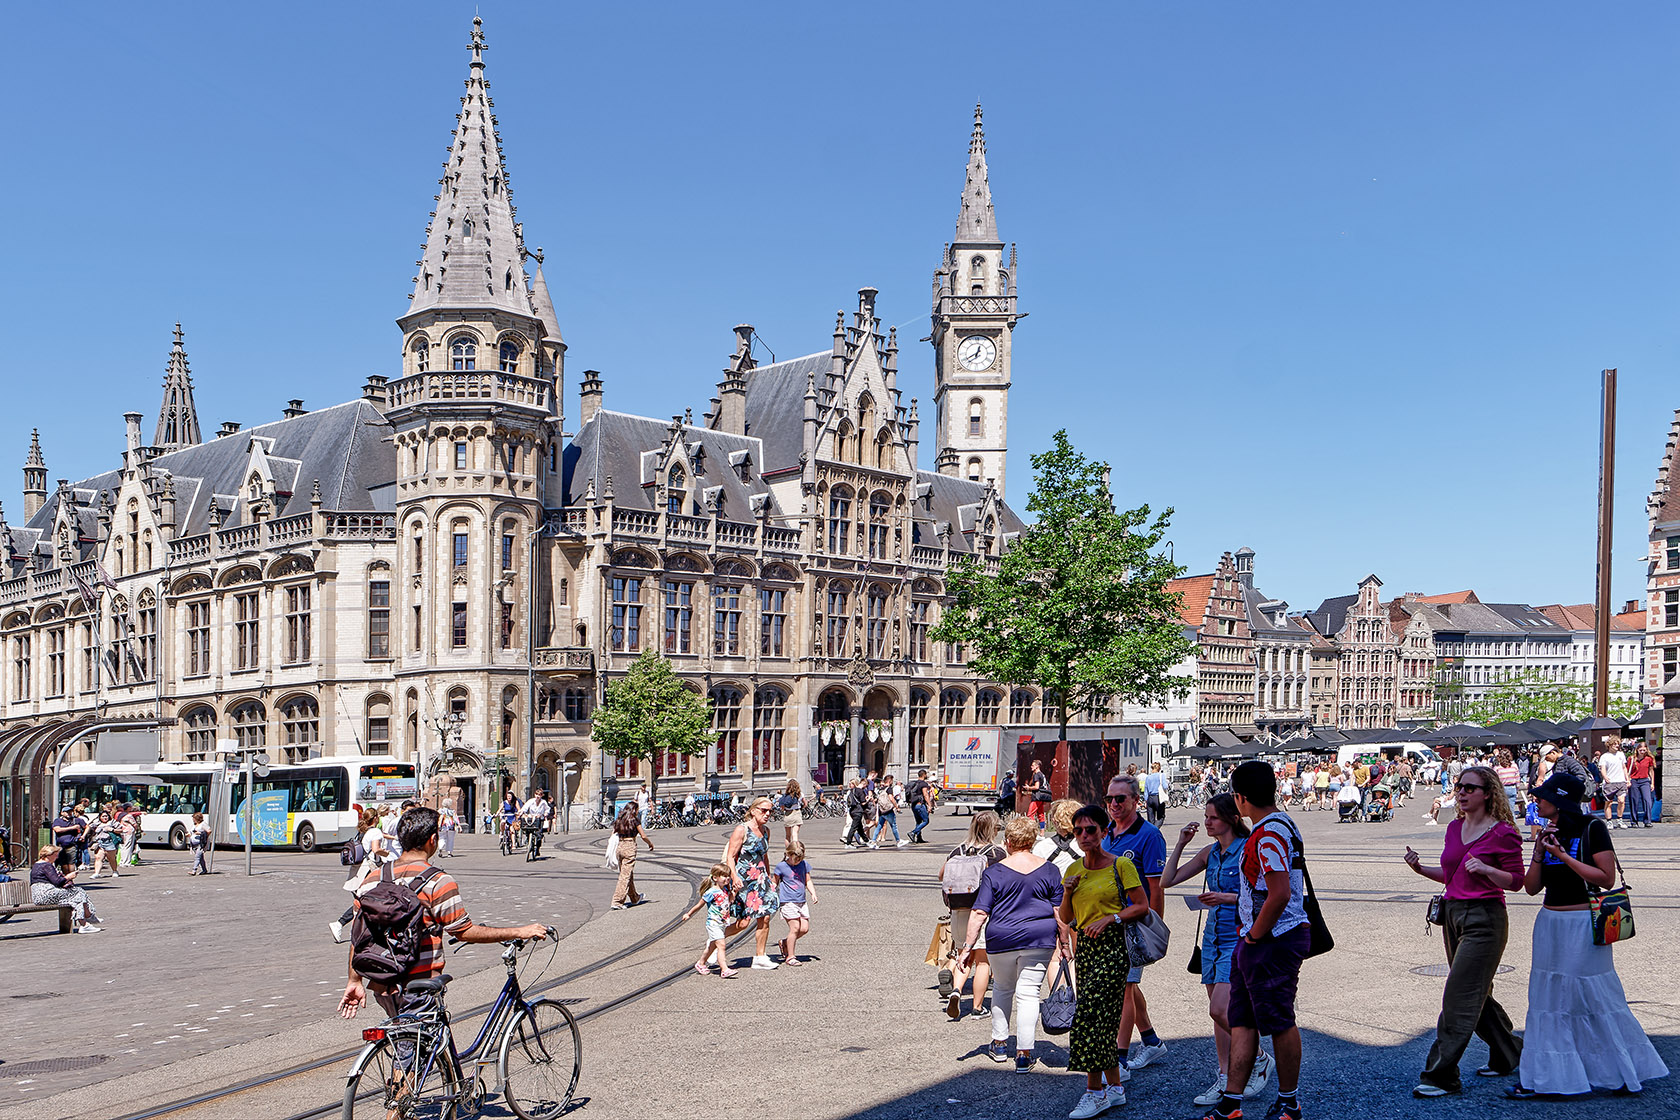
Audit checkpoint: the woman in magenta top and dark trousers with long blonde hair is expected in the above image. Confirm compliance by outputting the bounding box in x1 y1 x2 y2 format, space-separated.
1406 766 1524 1096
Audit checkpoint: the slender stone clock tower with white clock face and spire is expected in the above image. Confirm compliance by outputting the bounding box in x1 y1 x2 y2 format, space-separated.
929 104 1018 497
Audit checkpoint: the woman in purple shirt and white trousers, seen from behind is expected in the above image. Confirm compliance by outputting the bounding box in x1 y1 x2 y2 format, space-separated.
961 816 1062 1073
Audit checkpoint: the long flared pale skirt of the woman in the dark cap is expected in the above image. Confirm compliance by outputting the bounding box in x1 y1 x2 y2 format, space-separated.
1520 908 1668 1093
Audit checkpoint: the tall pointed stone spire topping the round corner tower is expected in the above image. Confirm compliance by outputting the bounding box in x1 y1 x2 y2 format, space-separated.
408 17 531 316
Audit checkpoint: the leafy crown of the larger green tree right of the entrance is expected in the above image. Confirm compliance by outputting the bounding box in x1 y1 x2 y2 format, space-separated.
932 432 1196 739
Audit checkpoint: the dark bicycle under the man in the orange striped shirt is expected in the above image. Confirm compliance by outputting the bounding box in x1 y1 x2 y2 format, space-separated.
341 929 583 1120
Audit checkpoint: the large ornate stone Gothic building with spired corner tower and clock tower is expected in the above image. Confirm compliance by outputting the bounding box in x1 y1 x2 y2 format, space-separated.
0 20 1075 823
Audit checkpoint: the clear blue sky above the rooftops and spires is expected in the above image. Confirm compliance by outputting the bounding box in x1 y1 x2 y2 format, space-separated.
0 3 1680 608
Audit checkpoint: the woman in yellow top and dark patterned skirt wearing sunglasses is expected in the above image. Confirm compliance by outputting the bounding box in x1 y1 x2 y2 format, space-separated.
1057 804 1149 1120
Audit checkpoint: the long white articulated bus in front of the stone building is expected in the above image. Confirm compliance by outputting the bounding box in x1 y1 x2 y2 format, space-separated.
59 756 418 851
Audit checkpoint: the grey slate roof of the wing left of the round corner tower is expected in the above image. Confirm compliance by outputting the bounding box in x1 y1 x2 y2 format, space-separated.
13 400 396 539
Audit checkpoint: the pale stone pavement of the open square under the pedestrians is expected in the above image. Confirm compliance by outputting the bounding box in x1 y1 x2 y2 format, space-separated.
0 806 1680 1120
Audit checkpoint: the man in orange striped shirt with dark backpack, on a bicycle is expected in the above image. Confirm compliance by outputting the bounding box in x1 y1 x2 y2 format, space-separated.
338 806 548 1019
